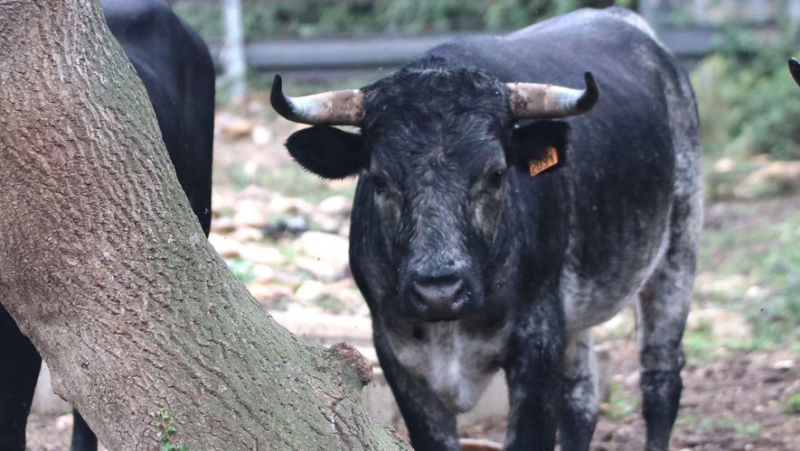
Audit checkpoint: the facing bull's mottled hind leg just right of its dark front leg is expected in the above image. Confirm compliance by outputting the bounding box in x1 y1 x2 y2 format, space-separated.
561 329 598 451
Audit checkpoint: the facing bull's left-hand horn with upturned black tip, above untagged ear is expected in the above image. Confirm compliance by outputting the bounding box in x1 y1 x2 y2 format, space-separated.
269 75 364 125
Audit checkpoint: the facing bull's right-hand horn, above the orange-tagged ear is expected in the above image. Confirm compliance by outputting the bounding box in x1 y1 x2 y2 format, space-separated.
507 72 600 119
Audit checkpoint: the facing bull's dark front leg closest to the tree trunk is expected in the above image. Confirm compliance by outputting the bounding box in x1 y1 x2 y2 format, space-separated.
374 328 460 451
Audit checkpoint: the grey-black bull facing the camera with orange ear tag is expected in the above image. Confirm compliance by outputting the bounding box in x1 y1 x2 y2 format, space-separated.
272 8 702 450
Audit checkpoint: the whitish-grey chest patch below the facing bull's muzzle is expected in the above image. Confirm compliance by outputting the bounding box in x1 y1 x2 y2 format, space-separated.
389 321 507 413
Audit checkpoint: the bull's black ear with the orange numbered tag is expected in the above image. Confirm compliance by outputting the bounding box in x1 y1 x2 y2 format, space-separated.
511 121 569 177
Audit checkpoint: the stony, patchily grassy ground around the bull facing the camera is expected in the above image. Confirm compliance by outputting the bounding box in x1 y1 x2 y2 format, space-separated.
21 100 800 451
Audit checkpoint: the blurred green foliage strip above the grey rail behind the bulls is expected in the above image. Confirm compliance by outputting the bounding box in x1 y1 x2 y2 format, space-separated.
175 0 635 39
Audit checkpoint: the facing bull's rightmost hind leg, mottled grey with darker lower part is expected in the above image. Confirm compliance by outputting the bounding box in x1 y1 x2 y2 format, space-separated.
637 207 700 450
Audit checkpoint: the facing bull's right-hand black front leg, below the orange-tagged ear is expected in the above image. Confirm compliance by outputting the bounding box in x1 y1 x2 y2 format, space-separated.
504 295 566 451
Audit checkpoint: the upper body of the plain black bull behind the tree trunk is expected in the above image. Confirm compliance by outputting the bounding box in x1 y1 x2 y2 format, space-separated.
101 0 215 234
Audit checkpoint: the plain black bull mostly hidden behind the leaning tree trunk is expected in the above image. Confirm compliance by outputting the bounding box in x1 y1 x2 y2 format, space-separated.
0 0 214 451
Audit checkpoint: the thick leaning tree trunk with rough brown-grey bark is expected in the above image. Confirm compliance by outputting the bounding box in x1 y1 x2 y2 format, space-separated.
0 0 407 450
